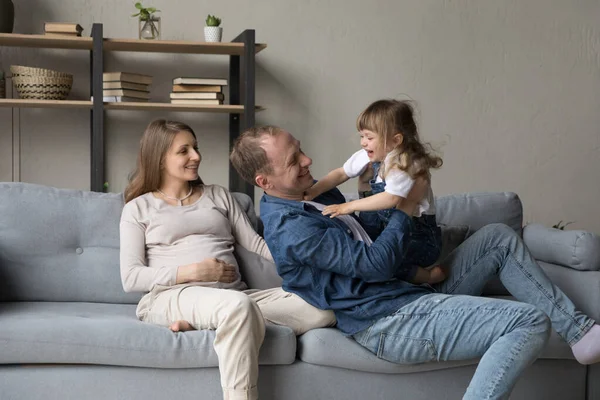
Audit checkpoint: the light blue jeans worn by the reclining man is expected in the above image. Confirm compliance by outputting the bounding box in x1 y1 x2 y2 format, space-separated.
354 224 594 400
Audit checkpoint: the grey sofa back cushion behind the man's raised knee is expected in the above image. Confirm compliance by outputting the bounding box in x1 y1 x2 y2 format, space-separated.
435 192 523 235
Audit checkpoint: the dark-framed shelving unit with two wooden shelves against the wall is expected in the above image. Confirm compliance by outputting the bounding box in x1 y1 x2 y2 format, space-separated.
0 24 267 198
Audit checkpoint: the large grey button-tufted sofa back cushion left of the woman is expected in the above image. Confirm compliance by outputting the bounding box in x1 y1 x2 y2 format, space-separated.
0 183 141 303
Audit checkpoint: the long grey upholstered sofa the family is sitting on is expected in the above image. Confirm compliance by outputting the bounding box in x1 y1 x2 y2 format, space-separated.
0 183 600 400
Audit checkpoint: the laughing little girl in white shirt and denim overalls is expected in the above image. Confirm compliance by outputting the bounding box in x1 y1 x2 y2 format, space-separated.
304 100 445 284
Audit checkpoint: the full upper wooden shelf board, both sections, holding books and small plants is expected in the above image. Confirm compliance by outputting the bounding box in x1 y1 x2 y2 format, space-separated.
0 33 267 55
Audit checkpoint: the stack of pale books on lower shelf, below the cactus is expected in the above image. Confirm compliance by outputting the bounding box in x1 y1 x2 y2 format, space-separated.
170 78 227 106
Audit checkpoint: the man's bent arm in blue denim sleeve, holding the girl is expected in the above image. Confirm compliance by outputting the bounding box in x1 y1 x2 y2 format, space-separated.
274 210 412 282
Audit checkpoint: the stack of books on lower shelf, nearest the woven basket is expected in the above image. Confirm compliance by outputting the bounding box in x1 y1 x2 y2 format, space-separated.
102 72 152 103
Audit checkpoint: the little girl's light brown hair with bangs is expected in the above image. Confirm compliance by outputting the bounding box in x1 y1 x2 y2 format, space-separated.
356 100 443 179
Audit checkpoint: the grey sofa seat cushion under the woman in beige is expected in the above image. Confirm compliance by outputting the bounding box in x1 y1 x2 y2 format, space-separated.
0 302 296 368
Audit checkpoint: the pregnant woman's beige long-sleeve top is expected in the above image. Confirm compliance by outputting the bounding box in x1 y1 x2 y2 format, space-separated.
120 185 273 315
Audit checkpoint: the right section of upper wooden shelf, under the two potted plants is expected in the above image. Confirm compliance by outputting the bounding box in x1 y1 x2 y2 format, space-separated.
103 39 267 55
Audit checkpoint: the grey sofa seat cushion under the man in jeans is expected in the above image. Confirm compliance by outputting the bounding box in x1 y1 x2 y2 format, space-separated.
298 306 574 374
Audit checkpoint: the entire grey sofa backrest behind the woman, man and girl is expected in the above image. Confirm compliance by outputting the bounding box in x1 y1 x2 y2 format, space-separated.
0 183 522 304
